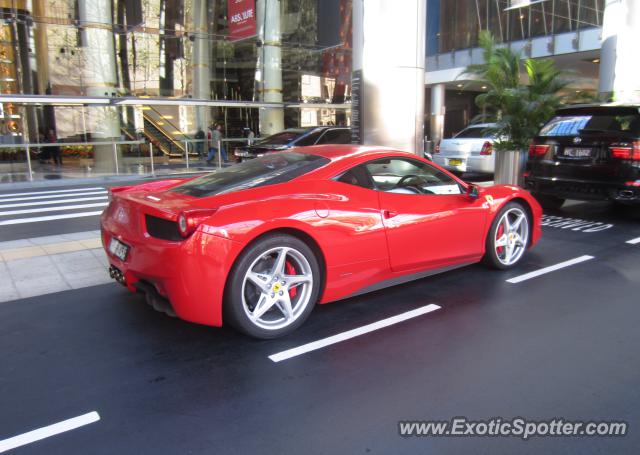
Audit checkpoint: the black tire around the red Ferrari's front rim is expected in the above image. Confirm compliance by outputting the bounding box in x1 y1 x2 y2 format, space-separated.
482 202 531 270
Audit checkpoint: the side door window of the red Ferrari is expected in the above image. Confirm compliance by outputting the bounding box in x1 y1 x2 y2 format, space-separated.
365 158 462 195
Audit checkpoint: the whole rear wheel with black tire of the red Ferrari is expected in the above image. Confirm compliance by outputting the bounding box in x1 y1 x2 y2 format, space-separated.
225 234 321 339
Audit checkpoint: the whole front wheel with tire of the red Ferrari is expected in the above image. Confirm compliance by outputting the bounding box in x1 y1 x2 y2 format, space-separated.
484 202 530 269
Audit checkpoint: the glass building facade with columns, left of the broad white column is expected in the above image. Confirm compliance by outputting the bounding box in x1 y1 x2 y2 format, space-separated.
0 0 351 182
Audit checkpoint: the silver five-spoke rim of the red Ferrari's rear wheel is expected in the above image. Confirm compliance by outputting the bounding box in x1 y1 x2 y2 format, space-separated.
242 247 313 330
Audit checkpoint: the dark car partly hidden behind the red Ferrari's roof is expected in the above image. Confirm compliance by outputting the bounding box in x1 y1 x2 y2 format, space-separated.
235 126 351 160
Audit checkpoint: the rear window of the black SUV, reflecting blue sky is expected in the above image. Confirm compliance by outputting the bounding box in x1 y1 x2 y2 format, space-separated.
539 114 640 136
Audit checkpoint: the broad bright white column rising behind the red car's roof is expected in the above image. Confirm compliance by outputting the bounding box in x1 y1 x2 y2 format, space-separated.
353 0 427 154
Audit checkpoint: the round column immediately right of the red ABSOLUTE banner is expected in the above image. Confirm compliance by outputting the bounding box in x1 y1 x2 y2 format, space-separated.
256 0 284 136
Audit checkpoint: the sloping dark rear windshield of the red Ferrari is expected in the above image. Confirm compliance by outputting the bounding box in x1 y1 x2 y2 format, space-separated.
171 152 329 197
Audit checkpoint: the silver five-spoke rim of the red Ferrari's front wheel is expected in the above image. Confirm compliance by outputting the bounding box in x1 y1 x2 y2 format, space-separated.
493 207 529 265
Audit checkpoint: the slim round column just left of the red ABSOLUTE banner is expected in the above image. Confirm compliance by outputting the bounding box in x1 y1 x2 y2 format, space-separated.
192 0 211 131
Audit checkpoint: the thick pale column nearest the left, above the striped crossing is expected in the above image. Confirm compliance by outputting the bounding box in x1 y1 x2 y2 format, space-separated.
78 0 120 172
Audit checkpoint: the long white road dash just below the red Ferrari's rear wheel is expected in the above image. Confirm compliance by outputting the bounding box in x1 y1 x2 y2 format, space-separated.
269 303 441 363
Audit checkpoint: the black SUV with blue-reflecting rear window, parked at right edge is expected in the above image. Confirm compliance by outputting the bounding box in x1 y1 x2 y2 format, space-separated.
525 104 640 208
